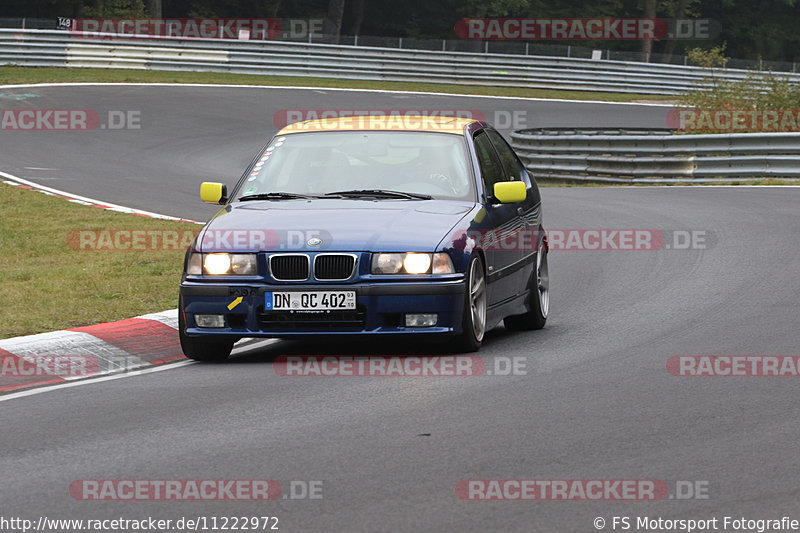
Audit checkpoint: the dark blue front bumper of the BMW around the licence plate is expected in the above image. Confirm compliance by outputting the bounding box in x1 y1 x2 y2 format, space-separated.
180 278 465 338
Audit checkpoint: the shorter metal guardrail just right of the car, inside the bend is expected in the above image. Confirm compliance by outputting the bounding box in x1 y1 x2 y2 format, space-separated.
511 128 800 183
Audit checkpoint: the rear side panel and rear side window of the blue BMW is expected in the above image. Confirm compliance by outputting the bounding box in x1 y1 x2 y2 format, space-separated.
486 129 542 278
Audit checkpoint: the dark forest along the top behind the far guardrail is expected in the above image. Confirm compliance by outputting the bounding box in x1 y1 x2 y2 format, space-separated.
0 0 800 62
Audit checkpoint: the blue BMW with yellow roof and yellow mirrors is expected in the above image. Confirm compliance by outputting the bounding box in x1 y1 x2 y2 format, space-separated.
179 116 549 361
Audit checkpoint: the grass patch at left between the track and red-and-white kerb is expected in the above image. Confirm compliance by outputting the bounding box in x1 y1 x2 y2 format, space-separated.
0 183 201 338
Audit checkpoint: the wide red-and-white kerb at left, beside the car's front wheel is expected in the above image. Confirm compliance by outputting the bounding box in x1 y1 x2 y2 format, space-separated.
0 309 184 393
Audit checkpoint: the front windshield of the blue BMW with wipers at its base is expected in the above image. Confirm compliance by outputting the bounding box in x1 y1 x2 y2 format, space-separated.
237 131 475 200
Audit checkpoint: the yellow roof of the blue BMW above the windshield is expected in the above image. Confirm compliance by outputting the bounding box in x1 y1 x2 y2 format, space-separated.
277 114 479 135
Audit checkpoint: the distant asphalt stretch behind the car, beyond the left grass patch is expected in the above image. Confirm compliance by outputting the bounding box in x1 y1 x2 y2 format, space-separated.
0 86 669 220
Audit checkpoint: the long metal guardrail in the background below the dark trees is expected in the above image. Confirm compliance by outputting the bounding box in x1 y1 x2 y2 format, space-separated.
0 29 800 95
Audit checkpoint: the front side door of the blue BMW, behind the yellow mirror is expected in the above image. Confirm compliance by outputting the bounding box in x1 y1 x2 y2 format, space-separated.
473 130 524 305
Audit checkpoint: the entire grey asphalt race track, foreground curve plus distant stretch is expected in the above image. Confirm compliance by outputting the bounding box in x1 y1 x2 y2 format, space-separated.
0 87 800 532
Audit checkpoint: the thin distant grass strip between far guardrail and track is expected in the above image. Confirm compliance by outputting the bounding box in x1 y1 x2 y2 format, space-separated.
0 66 675 102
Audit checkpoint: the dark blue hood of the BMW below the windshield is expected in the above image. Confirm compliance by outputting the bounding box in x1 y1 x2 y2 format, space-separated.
197 199 475 252
